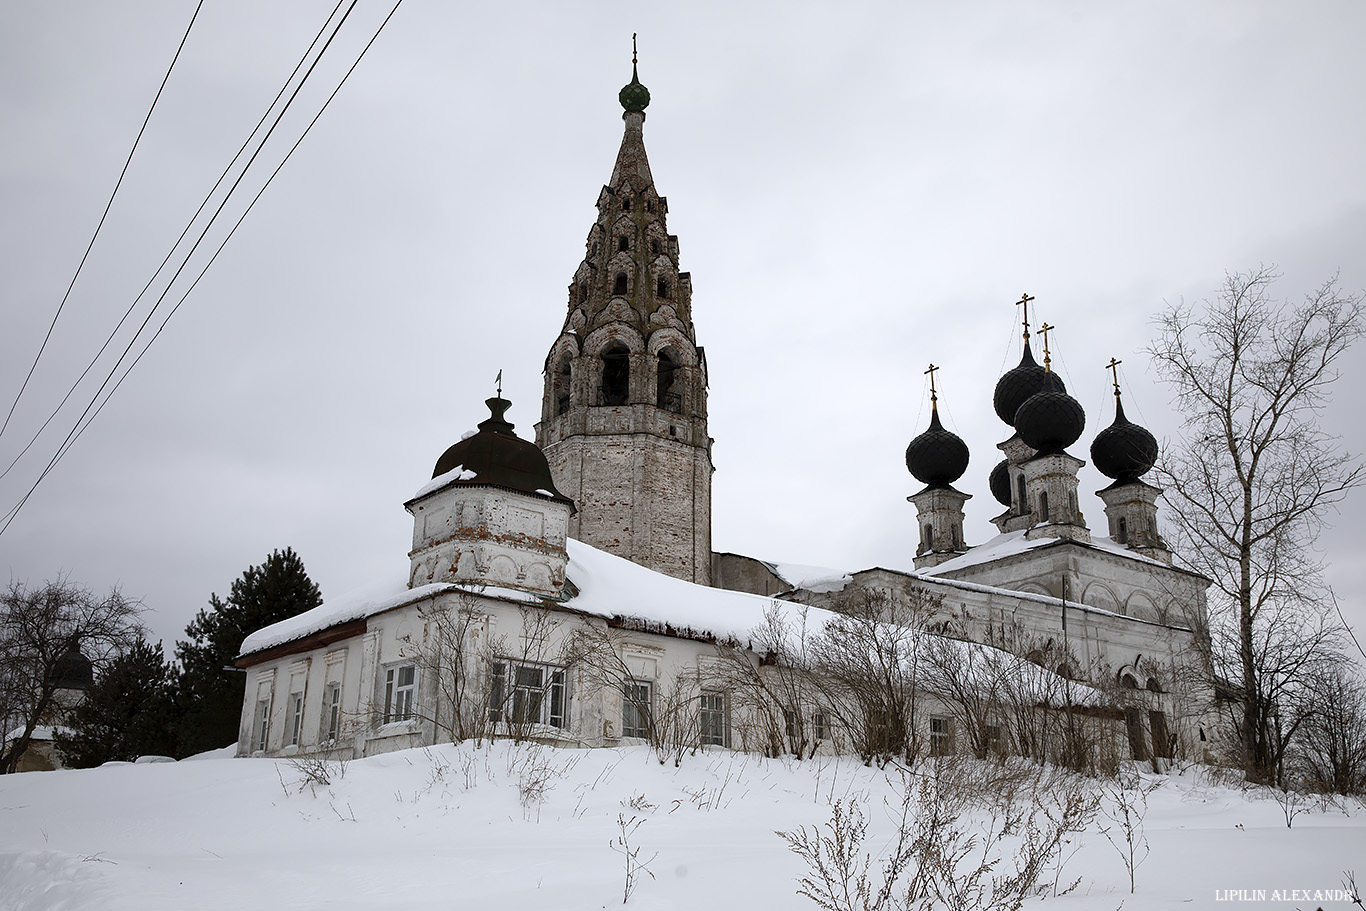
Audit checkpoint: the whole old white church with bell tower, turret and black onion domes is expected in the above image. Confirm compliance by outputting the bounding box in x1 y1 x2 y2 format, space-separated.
236 61 1213 759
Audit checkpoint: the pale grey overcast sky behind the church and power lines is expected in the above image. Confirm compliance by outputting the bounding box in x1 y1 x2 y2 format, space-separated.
0 0 1366 651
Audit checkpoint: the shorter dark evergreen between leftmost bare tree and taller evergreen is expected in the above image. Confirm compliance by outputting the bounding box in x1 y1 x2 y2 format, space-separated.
56 636 176 769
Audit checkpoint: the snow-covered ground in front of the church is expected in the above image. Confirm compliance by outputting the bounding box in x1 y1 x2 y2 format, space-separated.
0 743 1366 911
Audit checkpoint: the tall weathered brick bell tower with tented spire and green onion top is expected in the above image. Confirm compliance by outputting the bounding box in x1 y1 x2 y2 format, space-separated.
535 46 713 585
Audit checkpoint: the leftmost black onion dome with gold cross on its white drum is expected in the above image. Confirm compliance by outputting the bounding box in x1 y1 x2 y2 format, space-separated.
906 363 973 570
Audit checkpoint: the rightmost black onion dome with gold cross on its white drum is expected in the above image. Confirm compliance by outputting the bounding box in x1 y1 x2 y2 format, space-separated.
1091 358 1172 564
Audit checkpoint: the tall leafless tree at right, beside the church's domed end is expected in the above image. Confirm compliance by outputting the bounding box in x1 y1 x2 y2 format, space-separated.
1149 266 1366 781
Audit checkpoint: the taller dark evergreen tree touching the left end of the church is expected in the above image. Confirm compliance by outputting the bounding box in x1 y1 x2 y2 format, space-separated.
175 548 322 755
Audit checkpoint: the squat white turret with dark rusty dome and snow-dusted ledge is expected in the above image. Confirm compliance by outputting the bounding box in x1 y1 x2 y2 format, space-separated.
403 395 574 597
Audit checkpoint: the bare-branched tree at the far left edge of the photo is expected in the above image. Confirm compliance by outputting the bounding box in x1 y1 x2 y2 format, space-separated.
0 578 142 774
